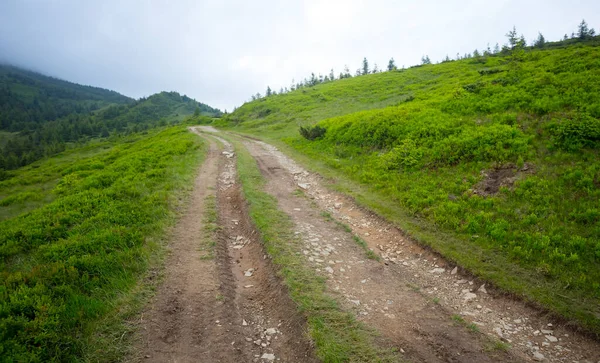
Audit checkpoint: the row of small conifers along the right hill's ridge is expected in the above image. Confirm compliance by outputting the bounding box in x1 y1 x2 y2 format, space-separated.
250 19 596 101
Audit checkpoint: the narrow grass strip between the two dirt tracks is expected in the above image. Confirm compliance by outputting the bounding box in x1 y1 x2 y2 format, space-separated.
234 135 398 362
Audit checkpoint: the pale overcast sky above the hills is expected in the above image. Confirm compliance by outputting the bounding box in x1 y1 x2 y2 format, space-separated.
0 0 600 111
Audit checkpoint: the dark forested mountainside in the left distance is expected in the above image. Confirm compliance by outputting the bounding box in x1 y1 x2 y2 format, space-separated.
0 66 220 173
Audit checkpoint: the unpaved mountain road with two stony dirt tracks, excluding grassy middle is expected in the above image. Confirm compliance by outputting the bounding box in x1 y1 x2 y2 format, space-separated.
132 127 600 363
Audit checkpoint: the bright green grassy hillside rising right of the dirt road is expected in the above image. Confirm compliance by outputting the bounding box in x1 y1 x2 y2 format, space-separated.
224 38 600 334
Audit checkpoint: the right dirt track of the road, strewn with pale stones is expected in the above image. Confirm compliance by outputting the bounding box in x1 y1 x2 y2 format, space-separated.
238 140 600 363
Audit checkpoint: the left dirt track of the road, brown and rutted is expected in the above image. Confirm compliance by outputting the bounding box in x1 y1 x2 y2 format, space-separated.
131 130 316 362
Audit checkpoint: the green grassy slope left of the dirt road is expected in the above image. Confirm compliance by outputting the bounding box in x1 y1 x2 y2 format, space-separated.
0 127 203 362
